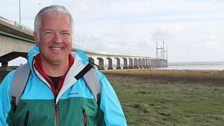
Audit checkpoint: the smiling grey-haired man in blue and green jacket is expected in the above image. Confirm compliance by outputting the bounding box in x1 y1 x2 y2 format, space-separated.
0 5 127 126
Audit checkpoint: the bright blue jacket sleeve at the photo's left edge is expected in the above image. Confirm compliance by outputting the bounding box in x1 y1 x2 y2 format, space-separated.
0 72 14 126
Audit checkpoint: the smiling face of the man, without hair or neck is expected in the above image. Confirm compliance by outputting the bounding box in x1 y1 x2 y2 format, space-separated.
34 13 72 64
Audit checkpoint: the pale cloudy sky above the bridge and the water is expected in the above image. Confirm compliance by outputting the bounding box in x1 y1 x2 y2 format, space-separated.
0 0 224 62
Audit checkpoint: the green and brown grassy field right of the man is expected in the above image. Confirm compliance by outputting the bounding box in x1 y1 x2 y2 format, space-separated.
103 70 224 126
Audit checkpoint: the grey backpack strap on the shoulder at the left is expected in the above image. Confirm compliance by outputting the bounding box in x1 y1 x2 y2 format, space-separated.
10 63 30 111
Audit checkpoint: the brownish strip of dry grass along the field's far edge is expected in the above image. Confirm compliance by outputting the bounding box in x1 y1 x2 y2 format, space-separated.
101 69 224 86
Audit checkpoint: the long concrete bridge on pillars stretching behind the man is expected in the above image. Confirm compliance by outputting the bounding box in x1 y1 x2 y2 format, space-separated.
0 17 167 70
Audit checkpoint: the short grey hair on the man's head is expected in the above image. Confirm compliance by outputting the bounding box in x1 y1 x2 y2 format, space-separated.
34 5 73 38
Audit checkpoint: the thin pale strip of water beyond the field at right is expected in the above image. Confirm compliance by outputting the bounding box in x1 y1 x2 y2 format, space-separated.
161 64 224 70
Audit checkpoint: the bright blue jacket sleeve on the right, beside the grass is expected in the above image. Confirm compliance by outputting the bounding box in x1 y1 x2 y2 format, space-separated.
98 73 127 126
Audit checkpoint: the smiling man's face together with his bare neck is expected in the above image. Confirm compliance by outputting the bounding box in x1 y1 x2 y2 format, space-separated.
34 7 72 76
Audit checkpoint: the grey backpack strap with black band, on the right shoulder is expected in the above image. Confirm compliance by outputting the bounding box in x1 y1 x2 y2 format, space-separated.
75 64 101 106
